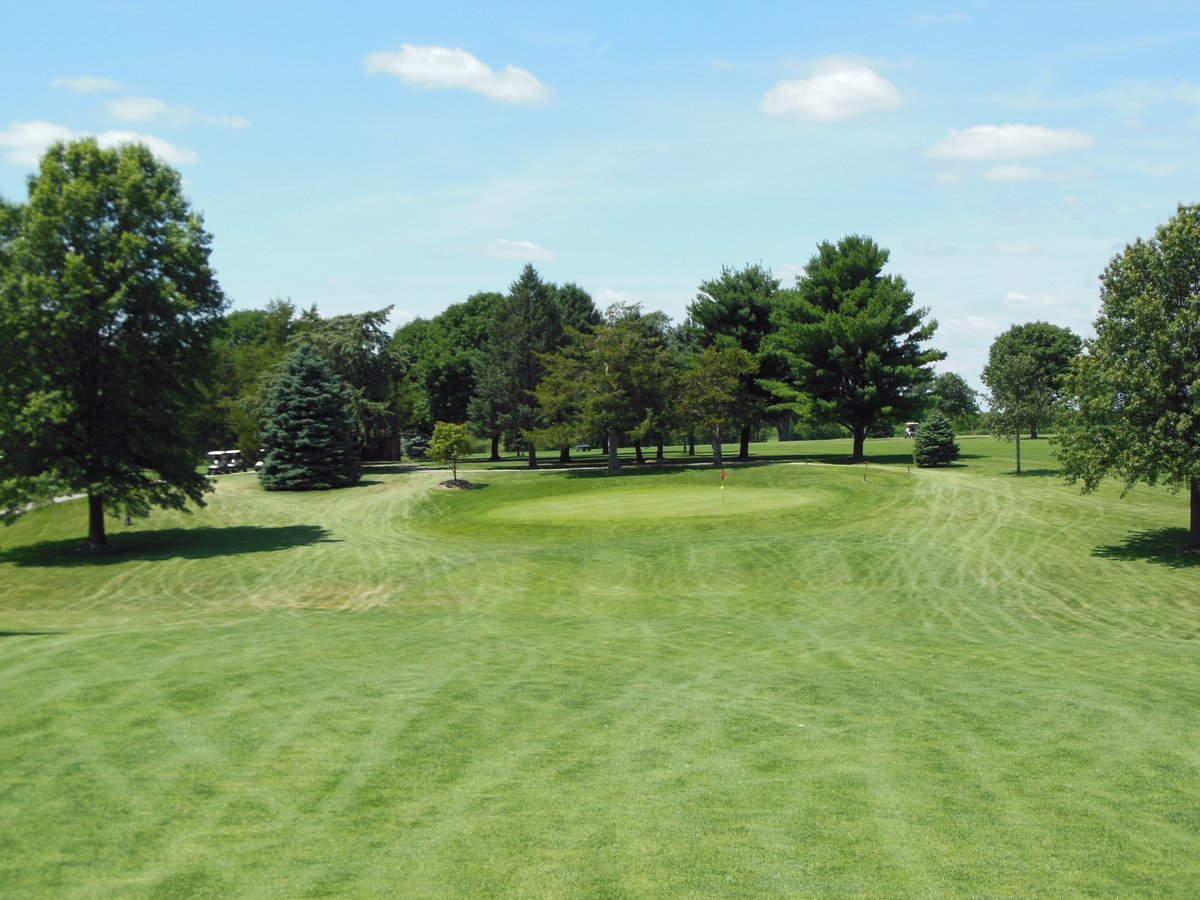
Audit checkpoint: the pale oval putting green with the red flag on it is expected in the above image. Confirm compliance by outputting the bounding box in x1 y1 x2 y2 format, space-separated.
486 485 821 524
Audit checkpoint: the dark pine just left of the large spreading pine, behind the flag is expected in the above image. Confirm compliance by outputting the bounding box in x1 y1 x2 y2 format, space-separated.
688 265 781 460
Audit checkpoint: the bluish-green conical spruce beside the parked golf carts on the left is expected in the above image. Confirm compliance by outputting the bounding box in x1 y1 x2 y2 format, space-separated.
258 343 362 491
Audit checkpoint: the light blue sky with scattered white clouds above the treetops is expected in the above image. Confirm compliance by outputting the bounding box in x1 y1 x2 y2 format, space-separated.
0 0 1200 386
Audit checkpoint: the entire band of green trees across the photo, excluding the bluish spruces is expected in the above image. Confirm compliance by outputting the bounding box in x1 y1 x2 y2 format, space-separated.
0 140 1200 547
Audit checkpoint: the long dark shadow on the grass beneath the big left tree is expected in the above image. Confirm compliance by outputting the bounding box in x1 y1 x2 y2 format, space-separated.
0 526 337 566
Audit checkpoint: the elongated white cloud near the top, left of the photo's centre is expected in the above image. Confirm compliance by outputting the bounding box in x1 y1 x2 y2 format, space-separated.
362 43 550 103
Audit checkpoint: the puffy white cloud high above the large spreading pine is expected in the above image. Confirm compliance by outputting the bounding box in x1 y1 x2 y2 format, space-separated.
758 56 904 122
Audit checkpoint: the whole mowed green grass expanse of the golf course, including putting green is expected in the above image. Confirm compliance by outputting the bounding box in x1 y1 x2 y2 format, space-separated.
0 439 1200 898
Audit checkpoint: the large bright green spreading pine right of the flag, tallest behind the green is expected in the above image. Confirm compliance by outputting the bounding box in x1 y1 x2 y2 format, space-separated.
770 235 946 461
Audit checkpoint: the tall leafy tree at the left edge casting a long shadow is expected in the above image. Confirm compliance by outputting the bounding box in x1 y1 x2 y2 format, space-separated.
0 139 224 550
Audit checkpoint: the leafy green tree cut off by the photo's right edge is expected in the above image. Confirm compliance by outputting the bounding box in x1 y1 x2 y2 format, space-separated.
1058 205 1200 550
